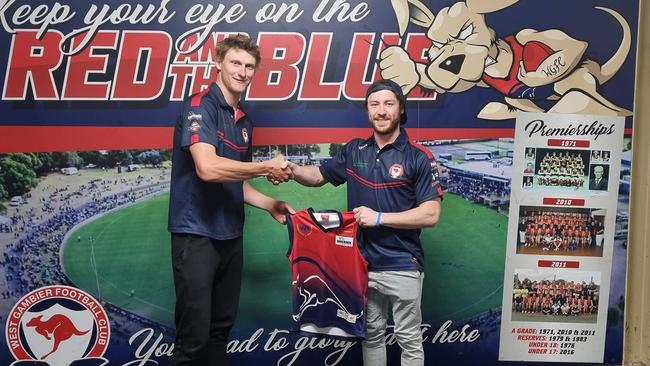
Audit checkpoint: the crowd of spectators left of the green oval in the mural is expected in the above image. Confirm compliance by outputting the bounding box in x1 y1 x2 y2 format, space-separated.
0 175 171 339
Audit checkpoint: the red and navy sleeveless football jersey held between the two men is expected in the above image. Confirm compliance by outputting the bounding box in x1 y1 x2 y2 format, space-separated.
287 208 368 339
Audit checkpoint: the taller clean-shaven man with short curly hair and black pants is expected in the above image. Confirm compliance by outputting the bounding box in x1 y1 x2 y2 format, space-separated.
168 35 293 366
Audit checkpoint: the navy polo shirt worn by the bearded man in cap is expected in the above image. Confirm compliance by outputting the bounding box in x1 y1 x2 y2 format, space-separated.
320 129 442 271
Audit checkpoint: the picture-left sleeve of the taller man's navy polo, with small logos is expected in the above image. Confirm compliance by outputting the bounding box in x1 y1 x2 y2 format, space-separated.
178 103 217 150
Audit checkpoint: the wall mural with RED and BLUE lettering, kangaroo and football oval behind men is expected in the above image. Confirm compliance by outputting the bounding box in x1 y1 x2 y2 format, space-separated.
0 0 639 365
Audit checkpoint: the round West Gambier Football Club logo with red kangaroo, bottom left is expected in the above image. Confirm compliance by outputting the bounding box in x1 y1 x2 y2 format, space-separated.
5 285 110 366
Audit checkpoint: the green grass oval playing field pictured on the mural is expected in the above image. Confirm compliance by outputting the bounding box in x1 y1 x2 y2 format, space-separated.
63 179 507 327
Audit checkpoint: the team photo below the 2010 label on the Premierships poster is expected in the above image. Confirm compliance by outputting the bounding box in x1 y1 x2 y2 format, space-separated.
518 209 604 252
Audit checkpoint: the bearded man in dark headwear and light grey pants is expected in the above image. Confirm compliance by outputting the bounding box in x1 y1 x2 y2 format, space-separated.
291 80 442 366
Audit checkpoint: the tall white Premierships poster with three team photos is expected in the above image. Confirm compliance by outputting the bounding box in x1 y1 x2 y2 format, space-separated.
499 113 624 363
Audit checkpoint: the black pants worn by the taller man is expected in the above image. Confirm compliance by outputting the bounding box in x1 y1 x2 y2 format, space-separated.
172 234 243 366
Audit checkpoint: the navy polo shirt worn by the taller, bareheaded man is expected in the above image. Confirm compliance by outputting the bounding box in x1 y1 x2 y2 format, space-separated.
168 83 253 240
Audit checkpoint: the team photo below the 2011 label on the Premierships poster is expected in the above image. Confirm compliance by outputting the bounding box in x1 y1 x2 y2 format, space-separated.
512 278 600 316
